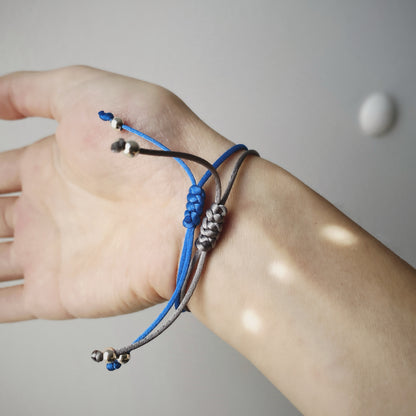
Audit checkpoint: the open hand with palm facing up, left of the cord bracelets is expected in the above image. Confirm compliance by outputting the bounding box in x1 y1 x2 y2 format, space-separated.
0 67 229 322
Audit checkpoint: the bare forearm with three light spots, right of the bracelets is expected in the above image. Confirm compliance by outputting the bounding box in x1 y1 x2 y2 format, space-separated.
190 154 416 415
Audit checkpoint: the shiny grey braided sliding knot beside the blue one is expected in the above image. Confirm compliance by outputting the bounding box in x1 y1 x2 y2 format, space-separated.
195 204 227 251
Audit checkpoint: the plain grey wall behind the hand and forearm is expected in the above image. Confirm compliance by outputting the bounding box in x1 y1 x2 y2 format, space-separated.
0 0 416 416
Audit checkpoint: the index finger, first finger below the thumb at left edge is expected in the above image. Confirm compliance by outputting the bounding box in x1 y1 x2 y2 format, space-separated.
0 147 25 194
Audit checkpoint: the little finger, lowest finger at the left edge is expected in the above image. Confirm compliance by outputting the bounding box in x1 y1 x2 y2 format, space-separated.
0 285 34 322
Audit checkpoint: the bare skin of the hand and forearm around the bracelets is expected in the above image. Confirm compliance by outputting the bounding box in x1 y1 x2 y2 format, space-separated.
0 67 416 415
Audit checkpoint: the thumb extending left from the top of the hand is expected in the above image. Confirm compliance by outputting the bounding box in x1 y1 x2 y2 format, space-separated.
0 66 98 120
